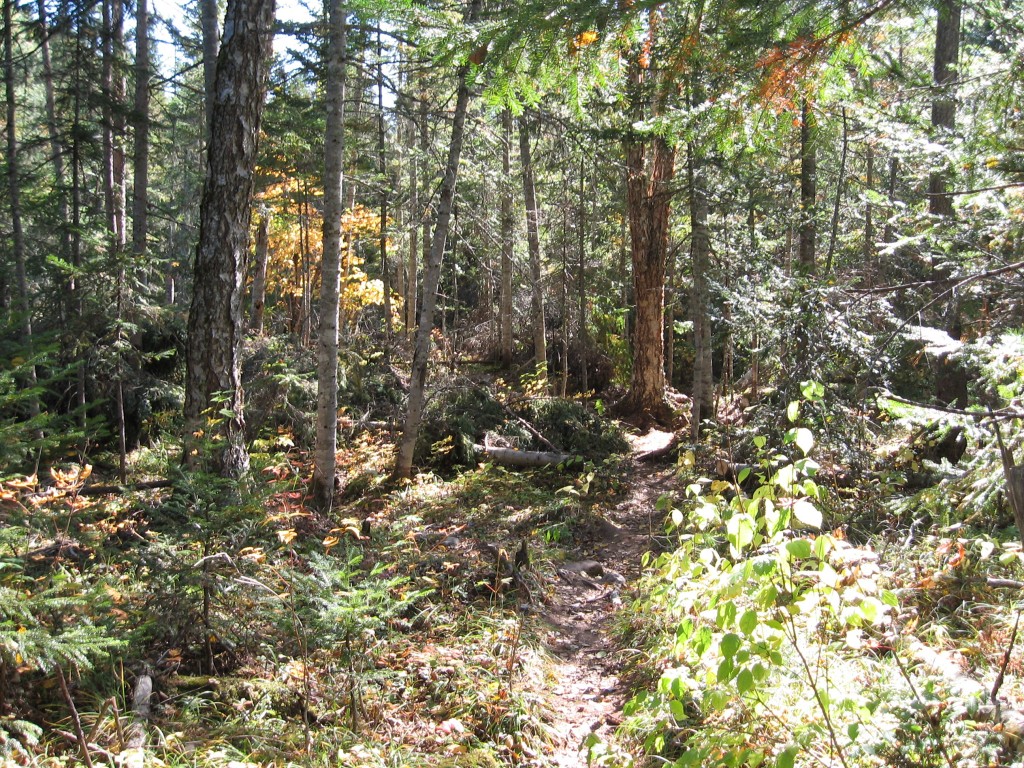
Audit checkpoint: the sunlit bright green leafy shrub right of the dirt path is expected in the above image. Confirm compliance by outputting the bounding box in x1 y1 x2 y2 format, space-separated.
590 382 995 768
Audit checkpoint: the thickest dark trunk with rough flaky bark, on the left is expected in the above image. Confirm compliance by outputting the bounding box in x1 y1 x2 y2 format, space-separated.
184 0 274 476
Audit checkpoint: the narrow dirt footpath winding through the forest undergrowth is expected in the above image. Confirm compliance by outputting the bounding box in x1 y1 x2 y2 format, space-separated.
543 452 672 768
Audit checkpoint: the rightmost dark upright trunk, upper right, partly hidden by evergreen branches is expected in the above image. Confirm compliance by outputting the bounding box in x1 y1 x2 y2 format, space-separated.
928 0 961 217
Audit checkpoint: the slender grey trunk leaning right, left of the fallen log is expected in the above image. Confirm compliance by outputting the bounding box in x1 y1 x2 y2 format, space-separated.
394 0 482 478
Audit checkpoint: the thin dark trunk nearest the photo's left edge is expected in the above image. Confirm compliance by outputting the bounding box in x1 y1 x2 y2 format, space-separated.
3 0 39 417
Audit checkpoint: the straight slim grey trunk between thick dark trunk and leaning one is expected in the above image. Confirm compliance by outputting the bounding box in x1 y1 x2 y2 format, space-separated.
312 0 347 511
